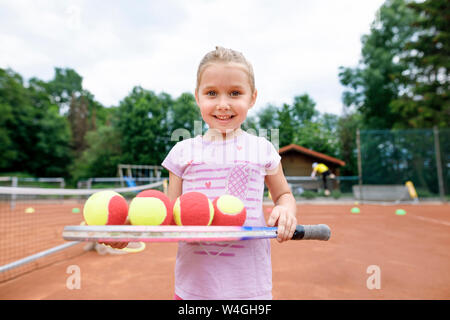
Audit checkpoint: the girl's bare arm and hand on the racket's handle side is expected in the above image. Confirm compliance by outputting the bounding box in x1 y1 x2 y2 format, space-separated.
265 163 297 242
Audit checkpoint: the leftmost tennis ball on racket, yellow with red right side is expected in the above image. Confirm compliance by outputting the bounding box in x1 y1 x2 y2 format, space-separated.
83 190 128 225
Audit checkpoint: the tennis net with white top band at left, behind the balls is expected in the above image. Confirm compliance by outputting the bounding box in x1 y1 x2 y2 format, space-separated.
0 180 166 283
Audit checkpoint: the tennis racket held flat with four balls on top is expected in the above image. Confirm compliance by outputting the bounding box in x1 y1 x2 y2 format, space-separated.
63 224 331 242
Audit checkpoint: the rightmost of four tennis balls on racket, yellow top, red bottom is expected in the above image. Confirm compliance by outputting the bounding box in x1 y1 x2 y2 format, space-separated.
212 194 247 226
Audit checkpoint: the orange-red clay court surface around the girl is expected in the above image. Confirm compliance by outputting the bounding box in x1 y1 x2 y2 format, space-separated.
0 204 450 300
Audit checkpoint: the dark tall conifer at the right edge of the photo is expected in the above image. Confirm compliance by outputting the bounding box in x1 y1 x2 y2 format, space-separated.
392 0 450 128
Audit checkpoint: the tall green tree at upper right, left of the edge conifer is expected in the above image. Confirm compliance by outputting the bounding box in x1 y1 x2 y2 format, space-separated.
339 0 417 129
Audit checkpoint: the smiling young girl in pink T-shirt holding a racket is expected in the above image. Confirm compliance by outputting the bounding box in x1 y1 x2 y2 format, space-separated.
162 47 297 300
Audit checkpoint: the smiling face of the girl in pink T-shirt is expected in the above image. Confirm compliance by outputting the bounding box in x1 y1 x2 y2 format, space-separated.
195 63 257 134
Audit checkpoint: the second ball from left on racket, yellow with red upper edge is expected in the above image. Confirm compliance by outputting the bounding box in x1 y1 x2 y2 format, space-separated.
128 189 172 226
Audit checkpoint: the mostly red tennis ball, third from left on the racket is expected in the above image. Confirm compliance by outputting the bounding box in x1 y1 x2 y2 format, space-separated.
173 191 214 226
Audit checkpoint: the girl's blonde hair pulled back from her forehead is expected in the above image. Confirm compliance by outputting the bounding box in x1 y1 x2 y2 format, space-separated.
195 46 255 92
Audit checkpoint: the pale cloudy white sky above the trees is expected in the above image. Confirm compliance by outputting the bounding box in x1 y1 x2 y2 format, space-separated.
0 0 384 115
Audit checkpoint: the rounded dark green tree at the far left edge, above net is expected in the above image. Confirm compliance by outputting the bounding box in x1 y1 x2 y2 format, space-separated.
0 69 70 176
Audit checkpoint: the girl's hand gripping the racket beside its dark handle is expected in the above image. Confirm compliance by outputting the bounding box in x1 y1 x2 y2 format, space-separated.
267 205 297 243
